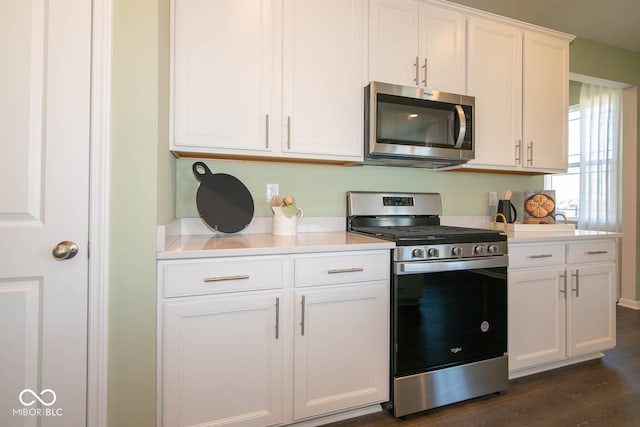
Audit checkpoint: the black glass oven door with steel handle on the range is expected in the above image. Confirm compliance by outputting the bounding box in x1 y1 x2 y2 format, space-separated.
392 256 507 377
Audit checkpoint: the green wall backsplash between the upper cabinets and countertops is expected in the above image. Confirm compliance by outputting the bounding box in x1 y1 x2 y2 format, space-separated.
176 159 543 218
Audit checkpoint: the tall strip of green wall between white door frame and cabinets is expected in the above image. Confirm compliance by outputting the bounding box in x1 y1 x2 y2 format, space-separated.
107 0 164 427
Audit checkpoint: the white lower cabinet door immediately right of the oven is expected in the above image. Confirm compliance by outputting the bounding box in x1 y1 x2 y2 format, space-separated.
508 268 565 371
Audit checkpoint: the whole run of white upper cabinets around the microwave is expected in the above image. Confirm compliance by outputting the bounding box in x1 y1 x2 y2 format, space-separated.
170 0 571 173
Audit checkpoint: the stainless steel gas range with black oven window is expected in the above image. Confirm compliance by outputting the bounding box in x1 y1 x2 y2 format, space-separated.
347 192 508 417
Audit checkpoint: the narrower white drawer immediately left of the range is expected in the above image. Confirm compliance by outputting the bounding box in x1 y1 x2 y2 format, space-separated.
294 251 391 287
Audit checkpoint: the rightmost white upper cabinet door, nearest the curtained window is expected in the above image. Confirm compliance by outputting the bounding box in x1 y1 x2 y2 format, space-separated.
523 32 569 171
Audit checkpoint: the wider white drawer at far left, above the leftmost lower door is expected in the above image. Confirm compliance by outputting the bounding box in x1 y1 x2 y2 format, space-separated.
158 257 283 298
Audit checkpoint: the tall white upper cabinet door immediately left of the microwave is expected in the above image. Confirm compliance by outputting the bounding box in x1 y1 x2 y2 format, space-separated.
281 0 367 161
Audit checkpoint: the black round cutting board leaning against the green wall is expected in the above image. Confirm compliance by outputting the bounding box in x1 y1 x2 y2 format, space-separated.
192 162 254 233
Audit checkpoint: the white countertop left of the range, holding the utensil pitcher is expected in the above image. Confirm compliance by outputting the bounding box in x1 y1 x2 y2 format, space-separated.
157 231 395 260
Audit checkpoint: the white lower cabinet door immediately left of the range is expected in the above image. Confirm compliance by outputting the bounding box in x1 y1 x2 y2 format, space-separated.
294 281 389 420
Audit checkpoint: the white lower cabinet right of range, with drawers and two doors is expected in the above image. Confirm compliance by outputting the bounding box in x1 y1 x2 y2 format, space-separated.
508 239 616 377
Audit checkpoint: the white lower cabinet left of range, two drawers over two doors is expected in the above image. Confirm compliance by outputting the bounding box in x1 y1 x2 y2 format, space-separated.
158 250 389 427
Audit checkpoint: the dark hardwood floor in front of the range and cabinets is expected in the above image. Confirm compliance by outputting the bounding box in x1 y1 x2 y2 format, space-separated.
330 307 640 427
